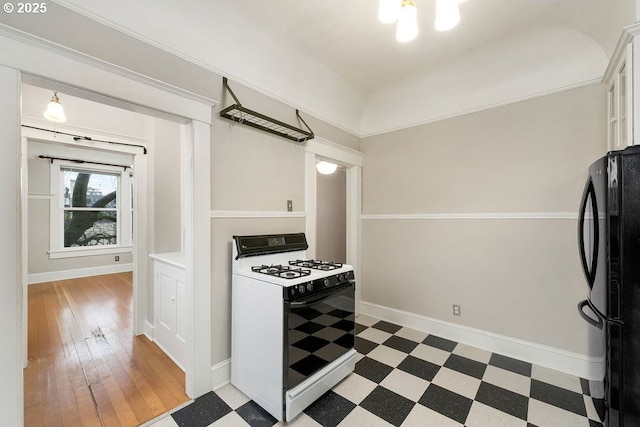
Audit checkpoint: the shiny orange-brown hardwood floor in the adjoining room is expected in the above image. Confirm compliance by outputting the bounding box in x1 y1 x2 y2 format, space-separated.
24 273 189 427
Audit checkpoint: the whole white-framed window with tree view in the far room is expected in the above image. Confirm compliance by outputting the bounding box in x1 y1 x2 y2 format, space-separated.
49 160 133 258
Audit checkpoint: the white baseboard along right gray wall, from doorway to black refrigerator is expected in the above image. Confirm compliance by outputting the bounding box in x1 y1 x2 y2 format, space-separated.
360 301 605 381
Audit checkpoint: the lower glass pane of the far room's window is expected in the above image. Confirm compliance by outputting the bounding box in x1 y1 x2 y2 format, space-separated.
64 210 118 248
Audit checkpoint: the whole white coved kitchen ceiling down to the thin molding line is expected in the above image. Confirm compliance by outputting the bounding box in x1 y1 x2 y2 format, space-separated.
45 0 636 136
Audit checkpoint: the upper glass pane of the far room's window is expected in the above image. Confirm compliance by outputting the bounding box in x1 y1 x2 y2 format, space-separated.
61 169 119 208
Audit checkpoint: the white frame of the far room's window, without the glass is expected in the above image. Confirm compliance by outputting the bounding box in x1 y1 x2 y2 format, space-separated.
49 160 133 259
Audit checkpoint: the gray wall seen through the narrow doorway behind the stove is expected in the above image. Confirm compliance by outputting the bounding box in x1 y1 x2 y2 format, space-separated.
315 168 347 263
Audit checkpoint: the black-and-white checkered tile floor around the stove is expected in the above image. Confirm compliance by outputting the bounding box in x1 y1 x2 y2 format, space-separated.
144 316 604 427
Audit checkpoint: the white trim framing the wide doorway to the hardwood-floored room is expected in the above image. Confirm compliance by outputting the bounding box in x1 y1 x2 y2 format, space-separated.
0 27 217 425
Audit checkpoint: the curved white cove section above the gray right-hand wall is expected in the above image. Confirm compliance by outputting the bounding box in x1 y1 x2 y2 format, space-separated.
362 26 608 136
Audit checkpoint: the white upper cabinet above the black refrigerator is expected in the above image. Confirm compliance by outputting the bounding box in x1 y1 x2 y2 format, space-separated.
603 24 640 150
